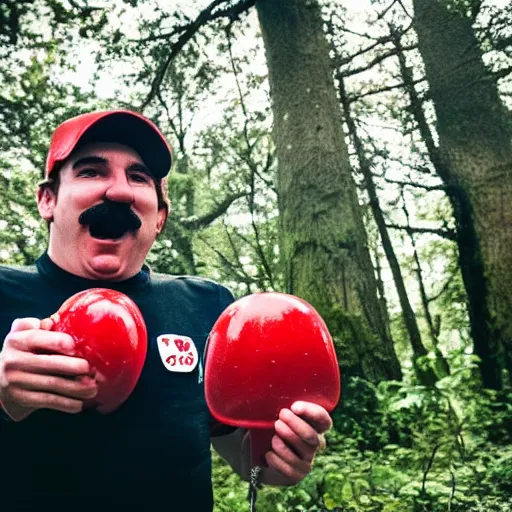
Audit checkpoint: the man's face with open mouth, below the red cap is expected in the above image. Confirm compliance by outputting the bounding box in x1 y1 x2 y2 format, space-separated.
38 143 166 281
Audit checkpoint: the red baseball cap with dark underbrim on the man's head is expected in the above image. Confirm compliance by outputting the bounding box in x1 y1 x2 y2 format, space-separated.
45 110 172 180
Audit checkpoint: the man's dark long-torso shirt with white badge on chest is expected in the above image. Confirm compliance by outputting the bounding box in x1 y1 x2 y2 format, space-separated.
0 254 233 512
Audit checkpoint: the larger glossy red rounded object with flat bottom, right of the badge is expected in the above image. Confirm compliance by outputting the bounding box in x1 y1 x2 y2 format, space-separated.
205 292 340 429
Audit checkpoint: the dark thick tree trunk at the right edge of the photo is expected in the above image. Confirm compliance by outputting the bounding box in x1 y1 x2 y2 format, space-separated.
400 4 512 389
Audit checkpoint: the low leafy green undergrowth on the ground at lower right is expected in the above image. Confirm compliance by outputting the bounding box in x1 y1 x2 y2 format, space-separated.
214 353 512 512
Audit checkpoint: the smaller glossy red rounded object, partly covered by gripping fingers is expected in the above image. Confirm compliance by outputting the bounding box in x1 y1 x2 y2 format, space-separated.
51 288 147 413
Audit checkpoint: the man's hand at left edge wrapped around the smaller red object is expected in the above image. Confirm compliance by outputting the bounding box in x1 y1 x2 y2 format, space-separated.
0 318 98 421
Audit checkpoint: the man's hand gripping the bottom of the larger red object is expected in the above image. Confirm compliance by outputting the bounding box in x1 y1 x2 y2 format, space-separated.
263 402 332 485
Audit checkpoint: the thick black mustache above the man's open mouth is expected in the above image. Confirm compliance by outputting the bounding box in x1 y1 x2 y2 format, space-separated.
78 200 142 238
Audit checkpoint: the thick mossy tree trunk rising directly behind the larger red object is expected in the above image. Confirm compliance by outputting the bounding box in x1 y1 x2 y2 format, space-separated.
256 0 401 381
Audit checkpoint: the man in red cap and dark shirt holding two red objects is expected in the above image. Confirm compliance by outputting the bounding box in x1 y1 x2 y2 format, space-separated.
0 111 331 512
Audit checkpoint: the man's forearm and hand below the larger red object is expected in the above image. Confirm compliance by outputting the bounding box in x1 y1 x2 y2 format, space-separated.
212 402 332 486
